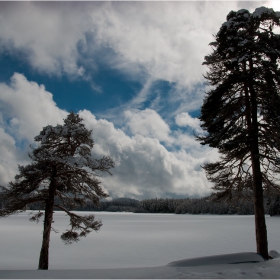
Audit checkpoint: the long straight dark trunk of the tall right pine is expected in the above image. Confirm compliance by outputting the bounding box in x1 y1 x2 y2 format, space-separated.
249 60 269 260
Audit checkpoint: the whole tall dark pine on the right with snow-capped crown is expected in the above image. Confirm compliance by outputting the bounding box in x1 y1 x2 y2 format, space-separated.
197 7 280 259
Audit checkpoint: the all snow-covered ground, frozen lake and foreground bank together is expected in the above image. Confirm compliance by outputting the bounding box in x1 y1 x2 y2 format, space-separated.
0 212 280 279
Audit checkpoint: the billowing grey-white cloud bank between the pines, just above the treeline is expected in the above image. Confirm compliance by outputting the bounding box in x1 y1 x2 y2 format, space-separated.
80 110 213 198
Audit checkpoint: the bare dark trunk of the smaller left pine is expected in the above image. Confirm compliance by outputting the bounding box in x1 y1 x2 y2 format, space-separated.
38 171 55 270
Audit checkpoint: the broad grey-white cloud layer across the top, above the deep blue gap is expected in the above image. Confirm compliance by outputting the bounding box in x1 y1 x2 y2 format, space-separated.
0 1 266 94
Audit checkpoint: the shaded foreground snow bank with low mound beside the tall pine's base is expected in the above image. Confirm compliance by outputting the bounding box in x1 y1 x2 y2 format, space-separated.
0 252 280 279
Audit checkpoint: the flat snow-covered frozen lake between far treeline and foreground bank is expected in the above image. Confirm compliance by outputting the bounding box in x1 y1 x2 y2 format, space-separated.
0 212 280 270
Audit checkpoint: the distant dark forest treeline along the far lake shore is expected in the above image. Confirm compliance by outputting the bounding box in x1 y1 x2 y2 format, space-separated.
0 195 280 216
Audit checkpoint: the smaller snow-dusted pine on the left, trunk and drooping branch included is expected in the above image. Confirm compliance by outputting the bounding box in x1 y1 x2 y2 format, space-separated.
0 113 114 269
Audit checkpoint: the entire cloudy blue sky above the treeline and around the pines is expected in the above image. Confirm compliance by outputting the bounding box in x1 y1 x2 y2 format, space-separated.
0 1 280 199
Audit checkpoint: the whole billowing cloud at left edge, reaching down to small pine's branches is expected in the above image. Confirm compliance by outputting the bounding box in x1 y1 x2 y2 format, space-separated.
0 73 67 184
